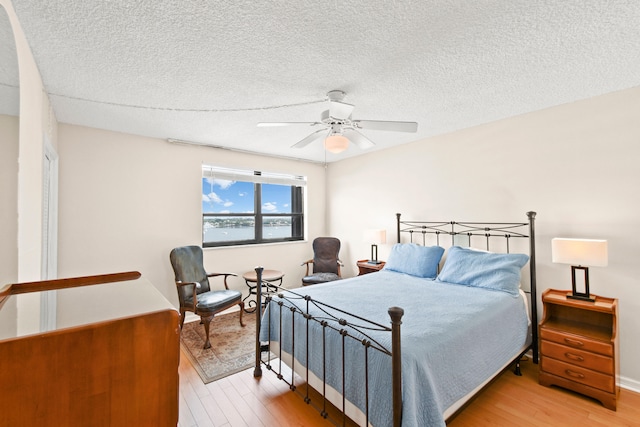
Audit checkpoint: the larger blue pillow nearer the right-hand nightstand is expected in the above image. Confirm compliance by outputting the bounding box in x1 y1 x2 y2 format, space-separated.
436 246 529 295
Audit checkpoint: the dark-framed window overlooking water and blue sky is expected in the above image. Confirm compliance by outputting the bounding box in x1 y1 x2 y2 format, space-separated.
202 165 306 247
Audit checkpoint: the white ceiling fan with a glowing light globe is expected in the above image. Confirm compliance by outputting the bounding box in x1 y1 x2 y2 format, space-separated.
258 90 418 153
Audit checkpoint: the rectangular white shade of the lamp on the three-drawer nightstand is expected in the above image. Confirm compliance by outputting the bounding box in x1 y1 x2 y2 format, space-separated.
551 237 609 267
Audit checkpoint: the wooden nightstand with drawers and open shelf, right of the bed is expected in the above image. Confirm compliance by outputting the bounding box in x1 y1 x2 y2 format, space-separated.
538 289 619 411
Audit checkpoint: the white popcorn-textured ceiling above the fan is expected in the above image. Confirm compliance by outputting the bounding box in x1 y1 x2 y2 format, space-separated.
7 0 640 161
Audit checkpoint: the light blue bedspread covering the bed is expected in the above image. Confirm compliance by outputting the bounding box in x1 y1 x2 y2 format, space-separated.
261 270 528 427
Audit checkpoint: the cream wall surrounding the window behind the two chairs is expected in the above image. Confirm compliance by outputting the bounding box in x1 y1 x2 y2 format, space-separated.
58 124 325 305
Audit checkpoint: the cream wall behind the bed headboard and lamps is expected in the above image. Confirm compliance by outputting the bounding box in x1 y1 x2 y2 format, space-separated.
327 88 640 390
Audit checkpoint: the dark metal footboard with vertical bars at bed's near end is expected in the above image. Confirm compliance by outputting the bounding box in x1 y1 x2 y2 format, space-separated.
253 267 404 427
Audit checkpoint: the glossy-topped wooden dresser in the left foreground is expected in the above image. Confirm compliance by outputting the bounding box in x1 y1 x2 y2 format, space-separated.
0 272 180 427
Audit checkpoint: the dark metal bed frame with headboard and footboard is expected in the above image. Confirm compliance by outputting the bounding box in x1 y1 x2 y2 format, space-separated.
253 212 538 427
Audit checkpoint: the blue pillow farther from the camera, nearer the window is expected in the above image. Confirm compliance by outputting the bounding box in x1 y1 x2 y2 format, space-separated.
384 243 444 279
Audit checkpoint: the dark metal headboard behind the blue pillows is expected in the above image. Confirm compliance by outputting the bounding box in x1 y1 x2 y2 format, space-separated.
396 211 538 363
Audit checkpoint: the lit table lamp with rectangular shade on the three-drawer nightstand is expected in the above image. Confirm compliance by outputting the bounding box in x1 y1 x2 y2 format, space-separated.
551 237 608 302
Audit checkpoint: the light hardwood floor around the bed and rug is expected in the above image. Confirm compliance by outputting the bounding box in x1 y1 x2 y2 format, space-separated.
178 354 640 427
